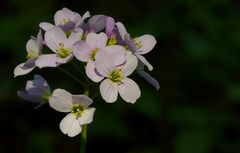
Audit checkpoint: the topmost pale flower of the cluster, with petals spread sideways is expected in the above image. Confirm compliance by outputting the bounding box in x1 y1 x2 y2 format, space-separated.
39 8 90 36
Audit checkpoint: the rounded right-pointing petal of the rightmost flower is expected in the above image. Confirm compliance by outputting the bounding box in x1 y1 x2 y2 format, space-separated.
137 34 157 54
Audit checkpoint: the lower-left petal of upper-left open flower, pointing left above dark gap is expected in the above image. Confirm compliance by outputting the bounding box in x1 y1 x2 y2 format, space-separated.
35 54 58 68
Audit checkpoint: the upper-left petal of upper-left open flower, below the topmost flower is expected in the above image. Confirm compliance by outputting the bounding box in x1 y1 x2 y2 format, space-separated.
45 27 67 52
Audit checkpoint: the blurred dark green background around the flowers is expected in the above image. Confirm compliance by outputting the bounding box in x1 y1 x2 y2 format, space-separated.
0 0 240 153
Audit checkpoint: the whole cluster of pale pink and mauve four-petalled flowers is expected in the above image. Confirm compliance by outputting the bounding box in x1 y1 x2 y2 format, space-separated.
14 8 159 137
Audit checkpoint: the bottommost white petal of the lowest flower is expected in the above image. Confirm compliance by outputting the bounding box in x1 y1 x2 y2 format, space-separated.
59 113 82 137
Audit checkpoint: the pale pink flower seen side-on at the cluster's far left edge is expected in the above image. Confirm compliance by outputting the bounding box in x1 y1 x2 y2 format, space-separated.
14 30 43 77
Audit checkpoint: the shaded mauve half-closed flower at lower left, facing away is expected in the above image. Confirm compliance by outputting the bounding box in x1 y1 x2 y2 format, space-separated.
18 75 51 106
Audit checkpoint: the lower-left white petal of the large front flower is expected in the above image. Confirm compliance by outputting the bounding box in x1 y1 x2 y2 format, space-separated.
100 79 118 103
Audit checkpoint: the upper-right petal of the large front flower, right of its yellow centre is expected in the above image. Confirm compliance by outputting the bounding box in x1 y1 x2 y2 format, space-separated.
122 52 138 76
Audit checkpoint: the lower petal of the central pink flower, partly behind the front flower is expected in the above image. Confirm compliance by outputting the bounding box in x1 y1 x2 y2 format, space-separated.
86 61 104 82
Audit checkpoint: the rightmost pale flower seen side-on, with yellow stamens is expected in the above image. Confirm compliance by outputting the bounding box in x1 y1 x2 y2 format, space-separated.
116 22 157 71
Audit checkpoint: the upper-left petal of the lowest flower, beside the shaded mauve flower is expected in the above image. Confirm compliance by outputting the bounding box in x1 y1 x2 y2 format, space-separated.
49 89 73 112
